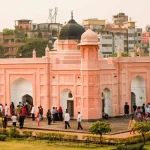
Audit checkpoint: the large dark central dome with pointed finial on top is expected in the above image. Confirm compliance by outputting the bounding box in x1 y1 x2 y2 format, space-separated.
59 12 85 40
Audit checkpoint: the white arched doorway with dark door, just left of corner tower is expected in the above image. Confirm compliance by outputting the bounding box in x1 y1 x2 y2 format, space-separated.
60 89 74 118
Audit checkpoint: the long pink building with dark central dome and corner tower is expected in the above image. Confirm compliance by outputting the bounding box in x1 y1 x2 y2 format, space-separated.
0 17 150 120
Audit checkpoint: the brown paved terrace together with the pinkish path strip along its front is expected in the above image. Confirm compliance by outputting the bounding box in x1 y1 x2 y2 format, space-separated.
5 117 140 140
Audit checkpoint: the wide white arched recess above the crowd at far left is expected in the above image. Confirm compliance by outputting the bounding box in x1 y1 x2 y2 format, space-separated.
11 78 33 107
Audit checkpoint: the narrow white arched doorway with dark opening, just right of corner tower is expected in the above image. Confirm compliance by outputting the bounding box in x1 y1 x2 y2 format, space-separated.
102 88 112 116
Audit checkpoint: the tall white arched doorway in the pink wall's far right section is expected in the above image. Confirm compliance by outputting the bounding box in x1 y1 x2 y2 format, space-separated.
131 76 146 107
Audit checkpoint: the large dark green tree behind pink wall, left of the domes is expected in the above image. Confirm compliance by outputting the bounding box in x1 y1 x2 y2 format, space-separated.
16 39 48 58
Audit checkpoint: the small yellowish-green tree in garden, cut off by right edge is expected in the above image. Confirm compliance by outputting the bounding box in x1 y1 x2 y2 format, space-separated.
133 122 150 144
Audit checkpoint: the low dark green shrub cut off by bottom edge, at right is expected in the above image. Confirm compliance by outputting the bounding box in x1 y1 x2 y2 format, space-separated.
117 144 144 150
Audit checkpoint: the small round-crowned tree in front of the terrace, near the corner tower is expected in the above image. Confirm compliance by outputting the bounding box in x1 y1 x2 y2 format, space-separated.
89 121 111 144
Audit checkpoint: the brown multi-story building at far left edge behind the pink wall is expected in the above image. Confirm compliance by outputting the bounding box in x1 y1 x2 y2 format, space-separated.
0 33 24 58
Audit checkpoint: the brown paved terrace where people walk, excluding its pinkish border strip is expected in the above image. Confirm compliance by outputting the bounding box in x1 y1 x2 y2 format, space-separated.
8 117 130 134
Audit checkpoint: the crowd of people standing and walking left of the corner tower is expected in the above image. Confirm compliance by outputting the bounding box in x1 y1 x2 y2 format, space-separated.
0 102 83 130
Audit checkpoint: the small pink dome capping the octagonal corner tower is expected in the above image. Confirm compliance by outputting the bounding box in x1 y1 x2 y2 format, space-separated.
79 29 99 45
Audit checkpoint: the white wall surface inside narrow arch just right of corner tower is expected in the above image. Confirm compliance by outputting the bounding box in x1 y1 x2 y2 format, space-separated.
103 89 112 116
